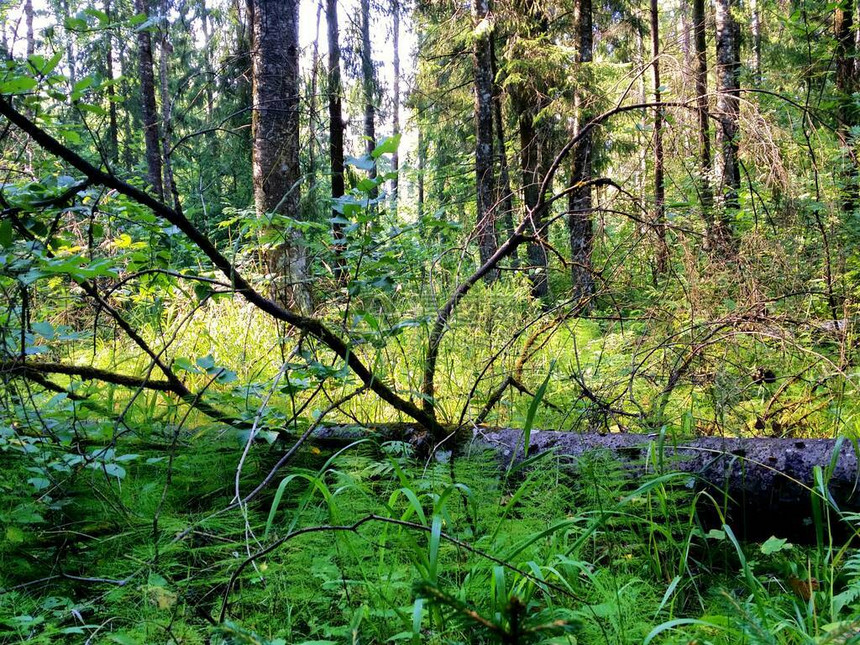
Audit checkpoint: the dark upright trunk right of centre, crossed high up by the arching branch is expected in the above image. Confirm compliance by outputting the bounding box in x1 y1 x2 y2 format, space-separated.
567 0 594 306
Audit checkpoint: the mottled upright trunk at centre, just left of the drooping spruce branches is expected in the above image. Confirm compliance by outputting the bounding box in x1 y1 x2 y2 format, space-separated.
472 0 499 283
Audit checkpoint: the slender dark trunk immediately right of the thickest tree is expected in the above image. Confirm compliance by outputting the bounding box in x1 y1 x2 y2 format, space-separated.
326 0 346 281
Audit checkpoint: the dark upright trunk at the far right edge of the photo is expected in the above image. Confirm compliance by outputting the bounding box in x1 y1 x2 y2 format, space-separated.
834 0 860 215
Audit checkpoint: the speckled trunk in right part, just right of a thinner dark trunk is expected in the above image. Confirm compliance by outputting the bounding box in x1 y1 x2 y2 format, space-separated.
714 0 741 218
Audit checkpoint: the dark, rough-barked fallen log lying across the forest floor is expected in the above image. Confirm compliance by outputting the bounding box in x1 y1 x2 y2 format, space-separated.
315 424 860 541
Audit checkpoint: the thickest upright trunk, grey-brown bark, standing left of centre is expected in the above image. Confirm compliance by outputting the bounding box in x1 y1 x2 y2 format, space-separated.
249 0 311 311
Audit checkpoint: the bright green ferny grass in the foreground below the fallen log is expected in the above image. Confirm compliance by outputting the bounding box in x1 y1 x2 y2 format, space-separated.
0 426 860 644
